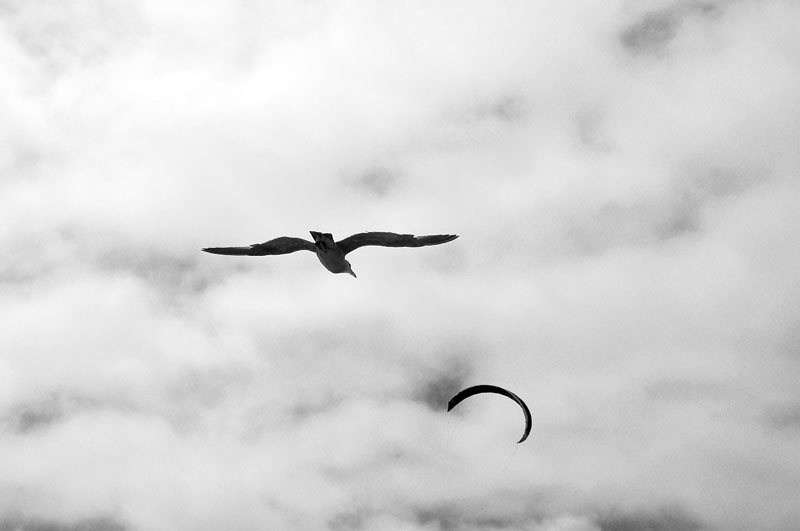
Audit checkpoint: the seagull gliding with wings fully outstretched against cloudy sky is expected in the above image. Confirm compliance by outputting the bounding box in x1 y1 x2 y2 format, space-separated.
203 230 458 277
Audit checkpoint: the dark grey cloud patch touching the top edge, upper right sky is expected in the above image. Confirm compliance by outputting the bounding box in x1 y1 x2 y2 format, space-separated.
619 2 720 55
